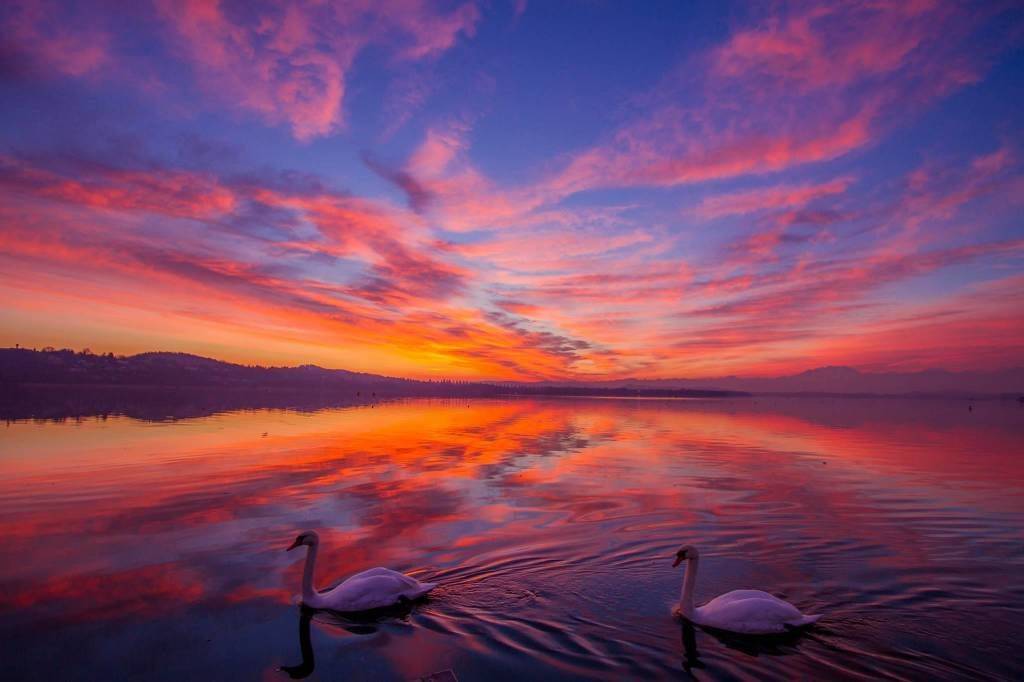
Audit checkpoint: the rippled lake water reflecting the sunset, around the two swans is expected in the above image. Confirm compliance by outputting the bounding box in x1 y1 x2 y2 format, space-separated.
0 398 1024 681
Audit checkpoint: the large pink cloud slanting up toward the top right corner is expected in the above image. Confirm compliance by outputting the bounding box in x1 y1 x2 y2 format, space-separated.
547 2 998 196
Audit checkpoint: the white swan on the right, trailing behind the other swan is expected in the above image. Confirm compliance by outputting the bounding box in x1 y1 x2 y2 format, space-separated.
672 545 821 635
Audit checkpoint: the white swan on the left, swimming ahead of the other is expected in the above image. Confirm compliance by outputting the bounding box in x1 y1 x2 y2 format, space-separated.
286 530 437 612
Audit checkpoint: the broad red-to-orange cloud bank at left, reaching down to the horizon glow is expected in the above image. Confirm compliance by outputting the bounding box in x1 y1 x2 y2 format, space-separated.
0 157 618 377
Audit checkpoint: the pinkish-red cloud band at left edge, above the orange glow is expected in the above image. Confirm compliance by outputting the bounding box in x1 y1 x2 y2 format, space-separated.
0 152 466 310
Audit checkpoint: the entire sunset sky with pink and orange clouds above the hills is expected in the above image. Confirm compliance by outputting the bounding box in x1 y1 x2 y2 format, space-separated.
0 0 1024 379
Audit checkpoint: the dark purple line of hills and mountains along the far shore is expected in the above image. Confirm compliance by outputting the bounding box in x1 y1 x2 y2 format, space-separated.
0 348 1024 397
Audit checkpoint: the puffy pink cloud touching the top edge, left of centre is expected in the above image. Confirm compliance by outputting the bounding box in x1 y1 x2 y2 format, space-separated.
157 0 479 140
